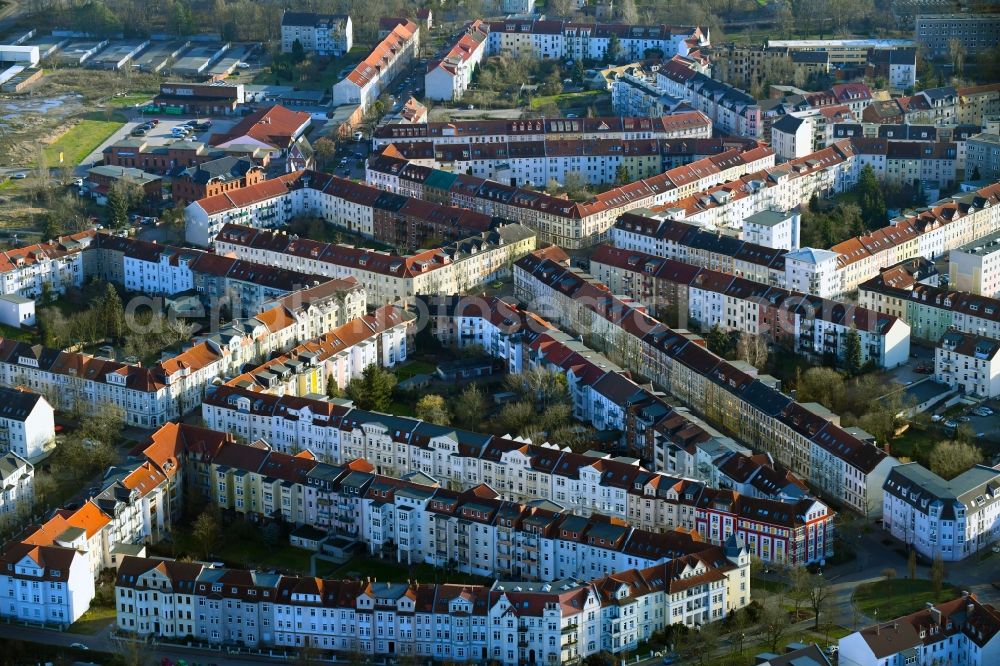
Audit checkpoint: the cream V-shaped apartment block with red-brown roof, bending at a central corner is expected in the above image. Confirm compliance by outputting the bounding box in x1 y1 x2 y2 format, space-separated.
215 224 536 305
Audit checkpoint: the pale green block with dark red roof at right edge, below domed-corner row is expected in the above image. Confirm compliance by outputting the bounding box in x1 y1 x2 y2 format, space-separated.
858 260 1000 344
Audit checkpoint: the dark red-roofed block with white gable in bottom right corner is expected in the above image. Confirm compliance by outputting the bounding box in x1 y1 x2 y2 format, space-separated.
837 593 1000 666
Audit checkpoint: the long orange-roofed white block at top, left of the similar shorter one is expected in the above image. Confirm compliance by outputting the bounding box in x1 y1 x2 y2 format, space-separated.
333 19 420 111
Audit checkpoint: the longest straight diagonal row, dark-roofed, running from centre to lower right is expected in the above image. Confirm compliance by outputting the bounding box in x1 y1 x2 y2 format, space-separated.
514 255 895 516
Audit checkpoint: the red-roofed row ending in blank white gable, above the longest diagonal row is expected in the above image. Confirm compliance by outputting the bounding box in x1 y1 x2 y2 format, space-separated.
591 245 910 367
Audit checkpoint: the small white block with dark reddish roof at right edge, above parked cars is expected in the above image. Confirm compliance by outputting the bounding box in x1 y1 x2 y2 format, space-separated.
934 331 1000 398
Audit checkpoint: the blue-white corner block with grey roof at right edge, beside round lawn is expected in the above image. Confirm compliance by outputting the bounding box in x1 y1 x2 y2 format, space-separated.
882 463 1000 562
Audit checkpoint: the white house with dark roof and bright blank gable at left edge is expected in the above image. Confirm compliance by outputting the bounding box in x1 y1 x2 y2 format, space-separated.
0 386 56 460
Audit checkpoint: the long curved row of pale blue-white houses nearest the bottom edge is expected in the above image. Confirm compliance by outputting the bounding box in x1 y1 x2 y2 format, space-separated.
115 543 749 666
